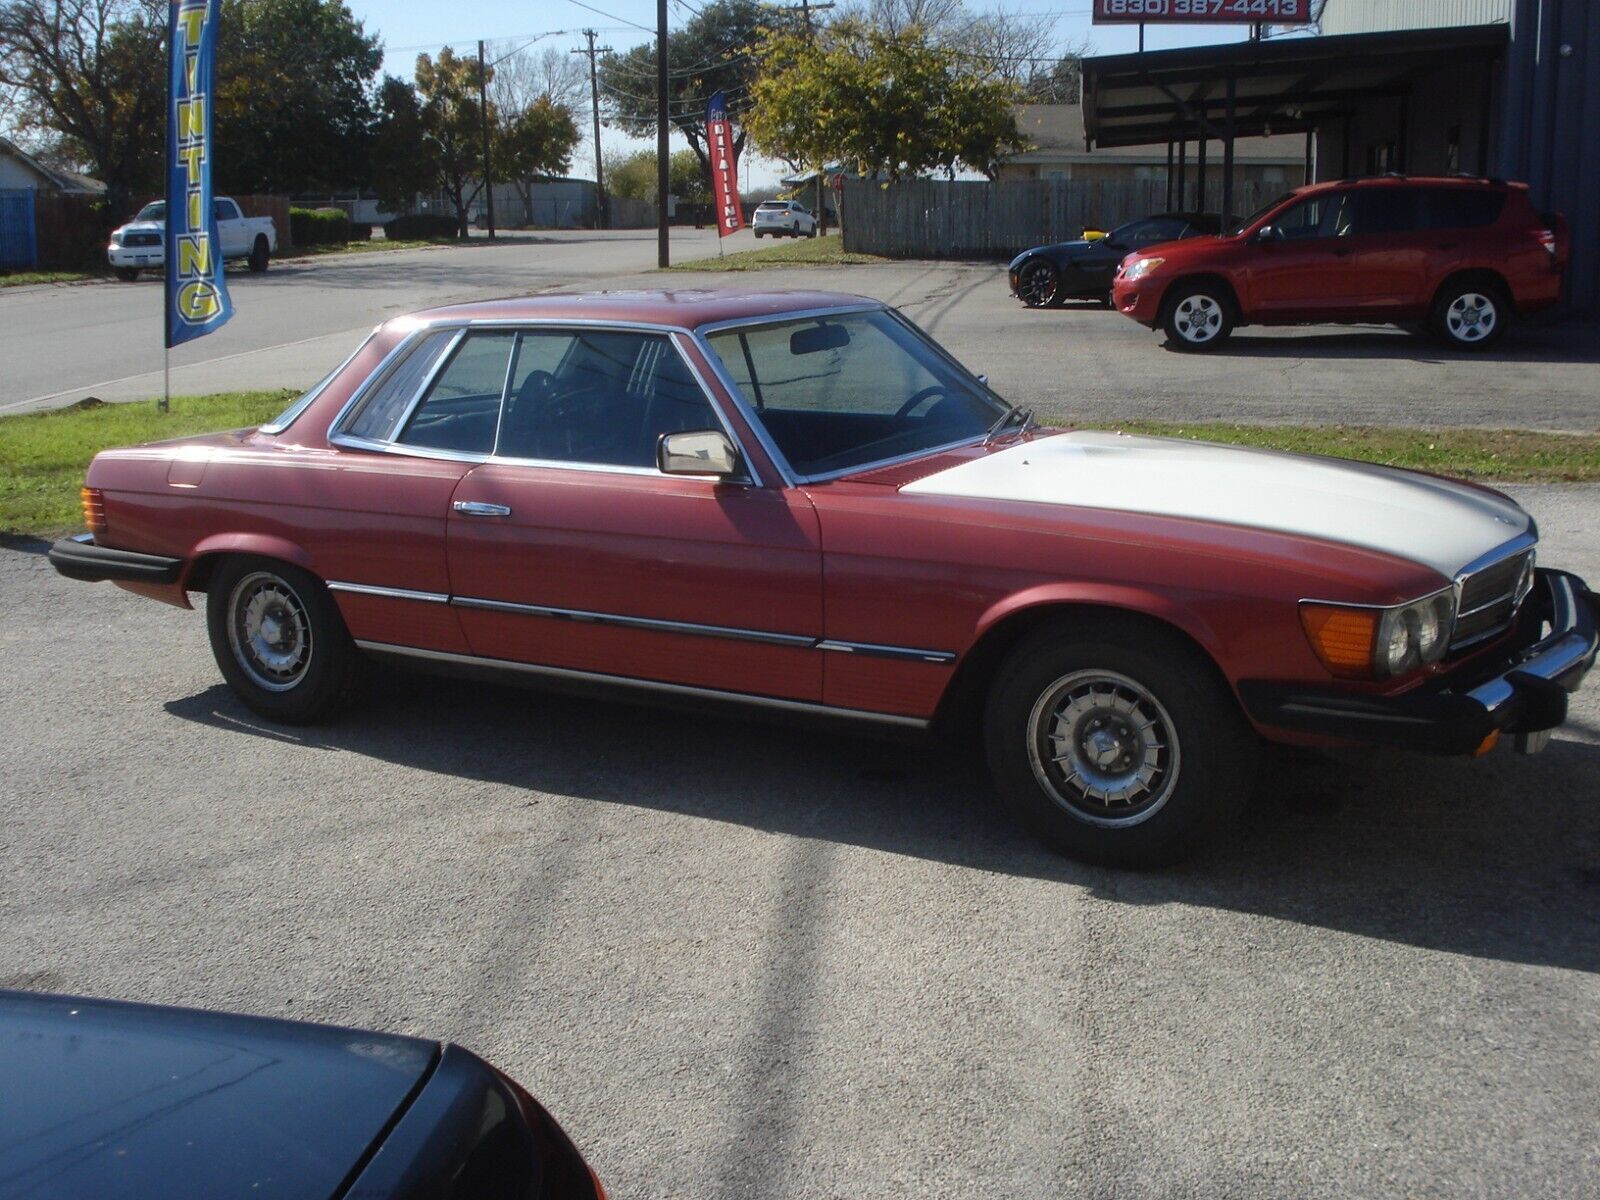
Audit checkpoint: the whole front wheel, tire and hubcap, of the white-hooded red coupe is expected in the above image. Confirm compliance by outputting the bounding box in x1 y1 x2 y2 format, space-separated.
984 619 1258 867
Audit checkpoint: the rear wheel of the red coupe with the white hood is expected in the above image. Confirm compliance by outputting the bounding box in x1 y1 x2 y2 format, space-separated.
206 555 366 725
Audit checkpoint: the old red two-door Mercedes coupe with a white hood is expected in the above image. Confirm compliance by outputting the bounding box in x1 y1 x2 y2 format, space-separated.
50 291 1597 862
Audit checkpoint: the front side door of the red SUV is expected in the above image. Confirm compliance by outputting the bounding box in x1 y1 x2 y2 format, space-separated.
1243 192 1360 322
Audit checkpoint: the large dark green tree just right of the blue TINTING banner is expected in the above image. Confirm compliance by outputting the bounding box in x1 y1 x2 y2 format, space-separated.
213 0 382 192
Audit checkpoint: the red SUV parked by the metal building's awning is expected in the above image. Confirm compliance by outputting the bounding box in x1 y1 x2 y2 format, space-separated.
1112 176 1568 350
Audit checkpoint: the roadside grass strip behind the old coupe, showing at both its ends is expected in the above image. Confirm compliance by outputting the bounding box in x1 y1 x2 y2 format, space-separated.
0 390 1600 538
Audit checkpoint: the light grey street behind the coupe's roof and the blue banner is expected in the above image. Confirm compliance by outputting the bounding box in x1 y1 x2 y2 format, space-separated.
0 229 736 413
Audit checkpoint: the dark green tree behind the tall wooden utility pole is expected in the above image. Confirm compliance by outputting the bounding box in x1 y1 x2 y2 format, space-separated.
600 0 794 179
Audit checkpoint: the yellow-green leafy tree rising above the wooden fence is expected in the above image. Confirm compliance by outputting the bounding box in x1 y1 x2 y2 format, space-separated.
746 19 1026 179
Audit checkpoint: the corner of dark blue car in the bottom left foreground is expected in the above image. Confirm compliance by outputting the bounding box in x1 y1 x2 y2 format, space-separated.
0 992 605 1200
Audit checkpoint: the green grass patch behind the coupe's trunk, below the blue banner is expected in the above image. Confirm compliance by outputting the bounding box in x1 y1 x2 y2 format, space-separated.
0 390 296 538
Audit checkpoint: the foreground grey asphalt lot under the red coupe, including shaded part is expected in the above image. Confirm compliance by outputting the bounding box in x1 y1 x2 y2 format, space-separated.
0 488 1600 1200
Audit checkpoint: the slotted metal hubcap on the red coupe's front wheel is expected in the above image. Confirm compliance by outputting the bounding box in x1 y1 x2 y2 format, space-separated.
1029 670 1179 826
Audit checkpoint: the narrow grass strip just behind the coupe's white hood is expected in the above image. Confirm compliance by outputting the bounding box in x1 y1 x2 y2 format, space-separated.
1090 421 1600 483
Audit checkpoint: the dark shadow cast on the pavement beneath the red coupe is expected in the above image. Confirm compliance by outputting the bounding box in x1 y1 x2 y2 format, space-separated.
166 675 1600 971
